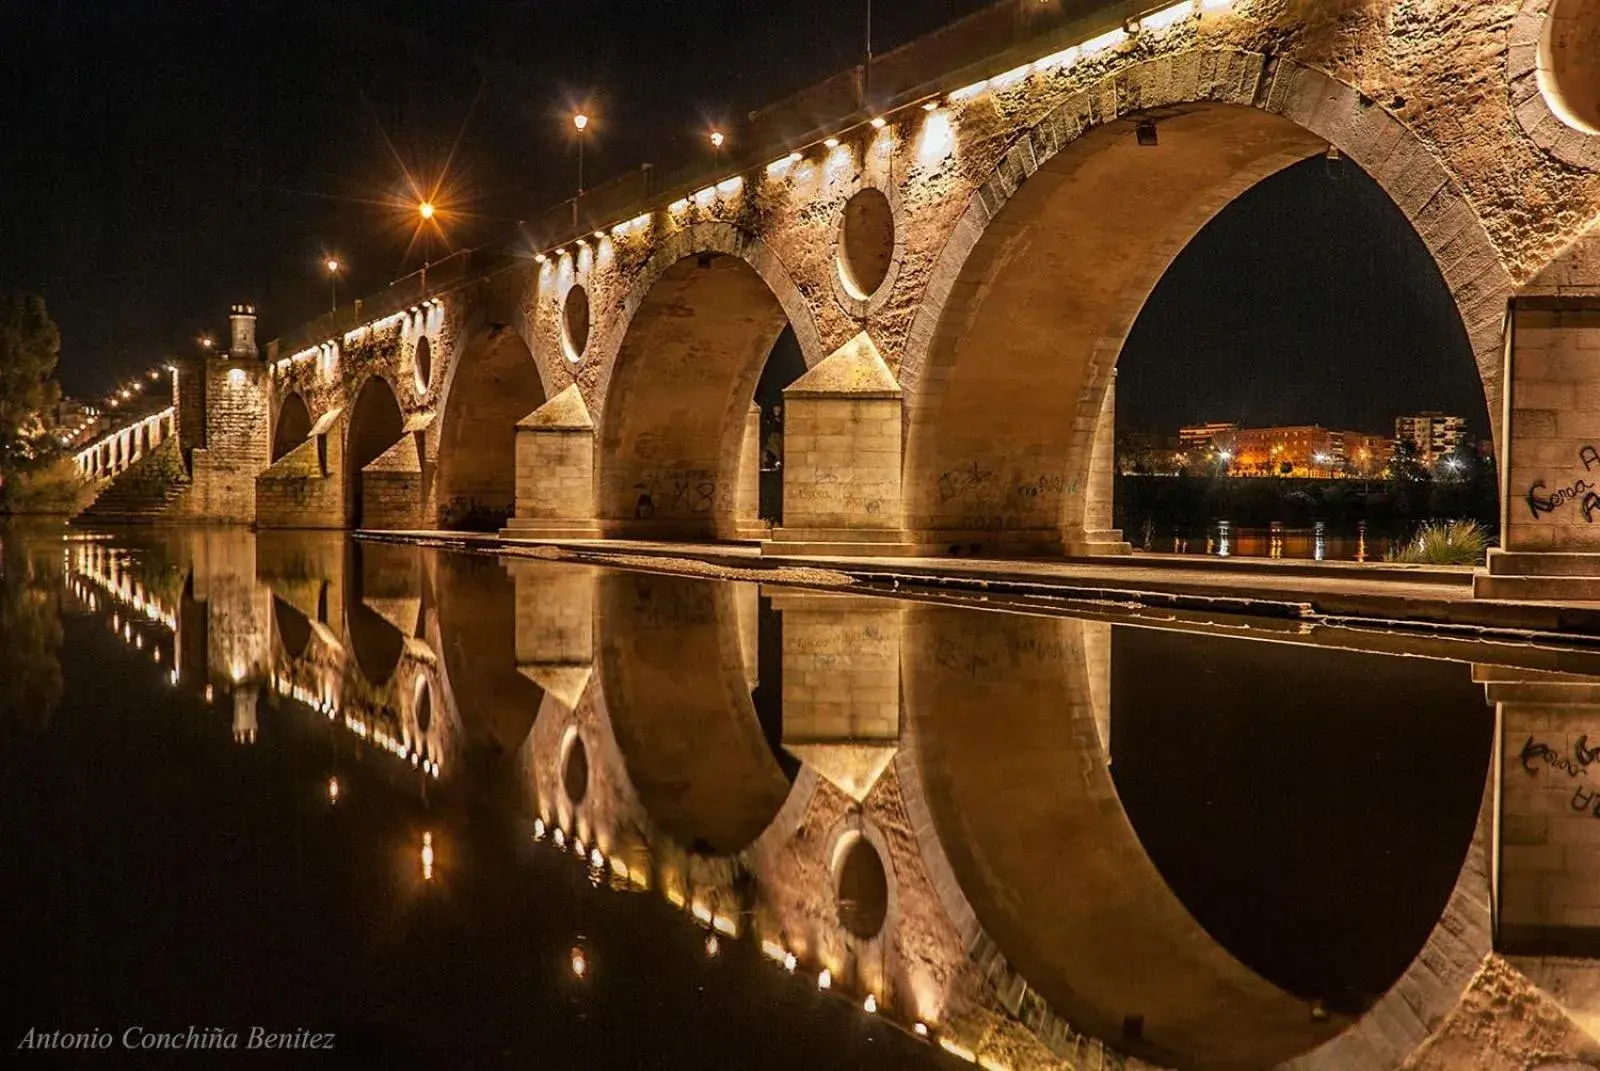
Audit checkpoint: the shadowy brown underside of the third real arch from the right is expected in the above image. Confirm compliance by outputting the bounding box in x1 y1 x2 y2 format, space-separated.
435 325 546 528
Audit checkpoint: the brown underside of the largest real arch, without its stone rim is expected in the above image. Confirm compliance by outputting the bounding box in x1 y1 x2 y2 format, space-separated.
906 104 1326 548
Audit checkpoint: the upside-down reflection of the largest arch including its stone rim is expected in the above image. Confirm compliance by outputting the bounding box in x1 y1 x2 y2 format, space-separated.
894 608 1491 1071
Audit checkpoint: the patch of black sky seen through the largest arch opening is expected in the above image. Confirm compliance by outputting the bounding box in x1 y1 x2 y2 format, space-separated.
1117 157 1490 437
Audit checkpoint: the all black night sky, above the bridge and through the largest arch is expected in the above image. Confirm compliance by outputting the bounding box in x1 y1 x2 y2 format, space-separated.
0 0 1486 431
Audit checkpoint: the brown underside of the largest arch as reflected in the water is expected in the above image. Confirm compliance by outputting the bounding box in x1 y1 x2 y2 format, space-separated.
904 610 1346 1068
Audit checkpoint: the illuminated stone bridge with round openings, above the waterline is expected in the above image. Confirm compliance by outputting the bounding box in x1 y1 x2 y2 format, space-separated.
75 0 1600 579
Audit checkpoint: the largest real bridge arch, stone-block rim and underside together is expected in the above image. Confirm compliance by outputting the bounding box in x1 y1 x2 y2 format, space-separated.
899 51 1510 549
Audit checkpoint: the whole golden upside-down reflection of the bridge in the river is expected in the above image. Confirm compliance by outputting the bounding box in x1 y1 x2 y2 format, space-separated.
46 533 1600 1068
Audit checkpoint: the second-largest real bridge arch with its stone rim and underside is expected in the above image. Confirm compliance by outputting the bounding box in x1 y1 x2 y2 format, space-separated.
586 223 826 538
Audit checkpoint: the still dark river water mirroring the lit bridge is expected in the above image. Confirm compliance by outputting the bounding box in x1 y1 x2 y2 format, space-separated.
0 528 1600 1068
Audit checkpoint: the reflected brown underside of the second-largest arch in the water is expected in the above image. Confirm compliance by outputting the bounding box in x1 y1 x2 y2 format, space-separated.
600 573 790 855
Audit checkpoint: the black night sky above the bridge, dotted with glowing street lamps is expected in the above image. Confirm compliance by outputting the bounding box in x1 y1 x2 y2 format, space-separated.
0 0 984 394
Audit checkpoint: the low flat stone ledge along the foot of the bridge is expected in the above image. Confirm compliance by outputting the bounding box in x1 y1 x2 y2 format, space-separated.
357 531 1600 645
